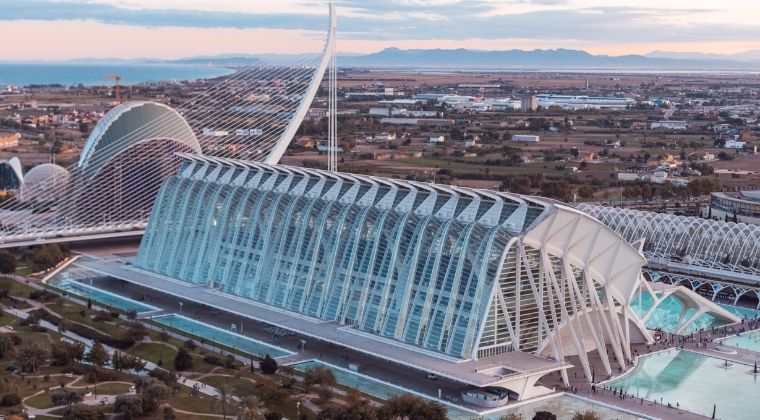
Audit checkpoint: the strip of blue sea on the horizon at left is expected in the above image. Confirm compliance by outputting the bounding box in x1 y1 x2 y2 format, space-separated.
0 63 234 86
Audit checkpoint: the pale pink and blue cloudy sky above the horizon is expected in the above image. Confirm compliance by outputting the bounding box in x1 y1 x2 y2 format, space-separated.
0 0 760 61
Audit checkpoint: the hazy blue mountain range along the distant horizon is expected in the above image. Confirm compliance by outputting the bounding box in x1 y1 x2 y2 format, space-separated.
5 48 760 71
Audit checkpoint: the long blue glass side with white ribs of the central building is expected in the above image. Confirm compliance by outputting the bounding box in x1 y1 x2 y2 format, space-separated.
135 155 547 358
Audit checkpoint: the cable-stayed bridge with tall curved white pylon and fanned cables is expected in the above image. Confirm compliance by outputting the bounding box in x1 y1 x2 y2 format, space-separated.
0 5 336 248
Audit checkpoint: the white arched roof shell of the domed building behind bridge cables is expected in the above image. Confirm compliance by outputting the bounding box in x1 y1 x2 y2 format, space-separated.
77 102 201 178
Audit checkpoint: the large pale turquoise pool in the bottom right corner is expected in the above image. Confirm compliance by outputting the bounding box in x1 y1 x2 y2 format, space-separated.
605 350 760 420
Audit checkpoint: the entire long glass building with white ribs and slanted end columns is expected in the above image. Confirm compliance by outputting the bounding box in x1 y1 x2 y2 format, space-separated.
134 154 651 384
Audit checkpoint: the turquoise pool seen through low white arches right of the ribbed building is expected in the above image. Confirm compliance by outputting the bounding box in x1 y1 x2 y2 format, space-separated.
631 291 724 334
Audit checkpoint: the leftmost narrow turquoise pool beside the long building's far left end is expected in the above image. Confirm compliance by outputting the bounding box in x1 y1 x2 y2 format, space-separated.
46 264 158 313
